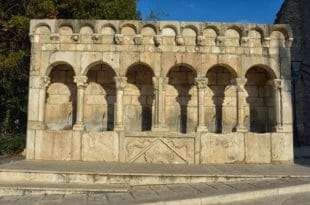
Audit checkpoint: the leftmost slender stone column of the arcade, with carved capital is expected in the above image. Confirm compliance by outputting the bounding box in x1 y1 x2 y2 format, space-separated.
37 76 50 129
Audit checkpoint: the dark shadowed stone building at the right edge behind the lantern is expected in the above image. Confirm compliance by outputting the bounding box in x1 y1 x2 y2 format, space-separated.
275 0 310 145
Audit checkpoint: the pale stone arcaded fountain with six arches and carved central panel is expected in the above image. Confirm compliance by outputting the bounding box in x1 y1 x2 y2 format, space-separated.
27 20 293 164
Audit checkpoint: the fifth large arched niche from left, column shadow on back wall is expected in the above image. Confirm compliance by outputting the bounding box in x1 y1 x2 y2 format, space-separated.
205 64 237 133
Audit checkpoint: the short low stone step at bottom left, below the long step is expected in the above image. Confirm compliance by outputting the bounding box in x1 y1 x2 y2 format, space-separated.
0 181 129 196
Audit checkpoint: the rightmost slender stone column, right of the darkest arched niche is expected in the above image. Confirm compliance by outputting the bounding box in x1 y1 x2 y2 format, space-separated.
271 79 283 132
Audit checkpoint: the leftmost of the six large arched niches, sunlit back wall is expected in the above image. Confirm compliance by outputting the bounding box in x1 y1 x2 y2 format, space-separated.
45 63 77 130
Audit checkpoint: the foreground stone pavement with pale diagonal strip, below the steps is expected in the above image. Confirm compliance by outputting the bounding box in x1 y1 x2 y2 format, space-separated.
0 178 310 205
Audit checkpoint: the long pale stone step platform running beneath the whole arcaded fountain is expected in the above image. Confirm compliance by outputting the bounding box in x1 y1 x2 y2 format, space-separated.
0 160 310 185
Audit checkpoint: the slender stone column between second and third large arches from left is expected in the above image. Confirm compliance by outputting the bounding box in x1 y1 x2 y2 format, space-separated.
114 77 127 131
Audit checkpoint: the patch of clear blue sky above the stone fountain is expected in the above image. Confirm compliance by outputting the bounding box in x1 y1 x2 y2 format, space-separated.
138 0 284 23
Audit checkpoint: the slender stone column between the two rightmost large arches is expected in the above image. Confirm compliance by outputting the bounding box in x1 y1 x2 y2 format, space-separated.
232 78 247 132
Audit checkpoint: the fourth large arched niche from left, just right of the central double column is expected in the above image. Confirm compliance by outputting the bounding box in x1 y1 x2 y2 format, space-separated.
166 64 197 134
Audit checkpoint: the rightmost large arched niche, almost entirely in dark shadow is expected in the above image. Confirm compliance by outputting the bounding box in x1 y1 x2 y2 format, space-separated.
245 65 276 133
